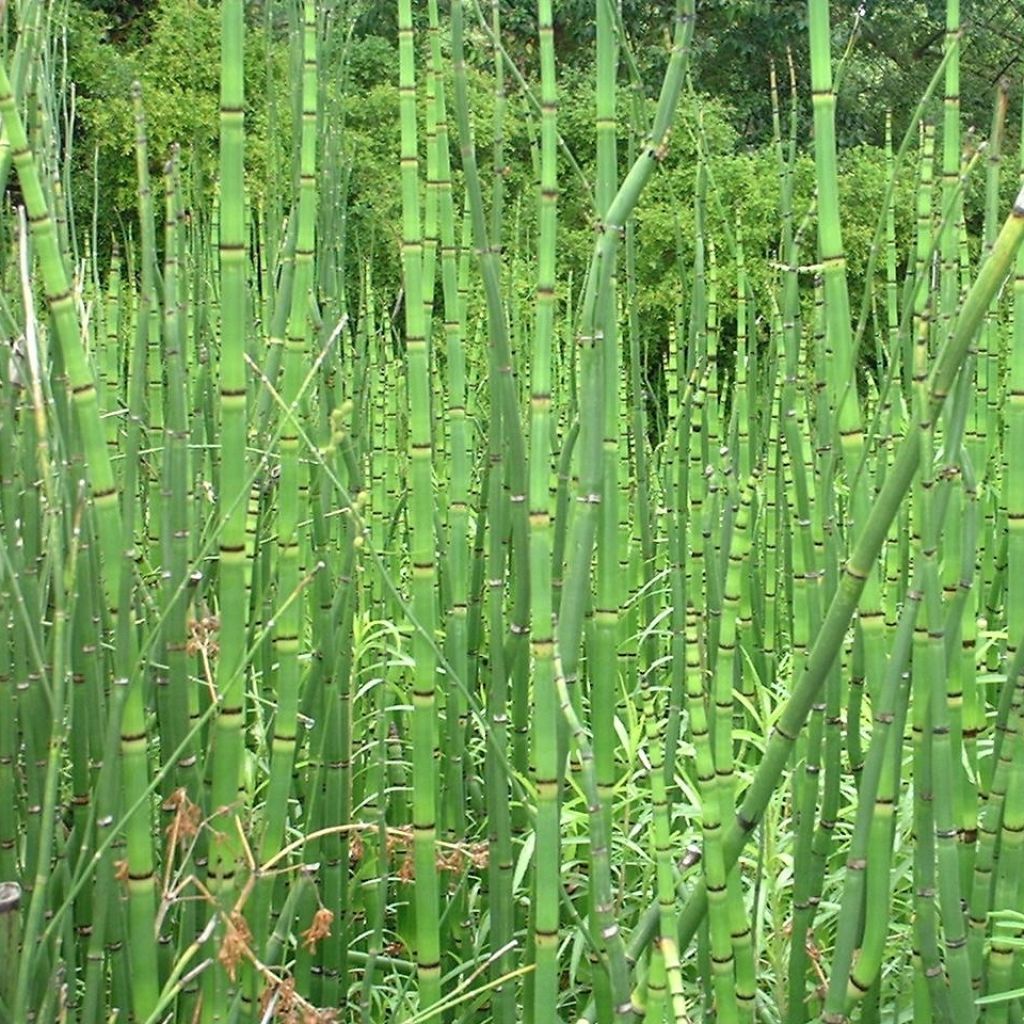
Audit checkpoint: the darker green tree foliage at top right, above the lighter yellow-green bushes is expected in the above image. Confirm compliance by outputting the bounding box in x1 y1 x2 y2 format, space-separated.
466 0 1024 145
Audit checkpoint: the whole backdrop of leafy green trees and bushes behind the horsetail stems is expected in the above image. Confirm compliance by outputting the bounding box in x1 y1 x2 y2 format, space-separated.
61 0 1024 315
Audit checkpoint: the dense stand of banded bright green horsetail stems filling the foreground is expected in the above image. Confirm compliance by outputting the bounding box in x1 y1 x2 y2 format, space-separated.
0 0 1024 1024
